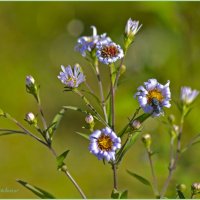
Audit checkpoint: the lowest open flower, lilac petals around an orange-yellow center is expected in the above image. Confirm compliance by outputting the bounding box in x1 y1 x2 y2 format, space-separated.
89 127 121 161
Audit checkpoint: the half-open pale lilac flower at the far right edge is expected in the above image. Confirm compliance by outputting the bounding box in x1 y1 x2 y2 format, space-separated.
181 87 199 105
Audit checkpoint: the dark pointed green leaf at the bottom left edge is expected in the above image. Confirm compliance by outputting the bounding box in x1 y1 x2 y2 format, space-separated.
17 180 56 199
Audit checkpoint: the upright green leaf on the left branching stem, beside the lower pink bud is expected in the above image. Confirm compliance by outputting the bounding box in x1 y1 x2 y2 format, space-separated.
47 108 65 140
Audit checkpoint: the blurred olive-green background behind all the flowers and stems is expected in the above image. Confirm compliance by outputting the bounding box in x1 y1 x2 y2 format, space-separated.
0 2 200 198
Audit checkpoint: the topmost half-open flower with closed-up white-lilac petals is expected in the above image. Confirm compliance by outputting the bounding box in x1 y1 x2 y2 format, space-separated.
125 18 142 37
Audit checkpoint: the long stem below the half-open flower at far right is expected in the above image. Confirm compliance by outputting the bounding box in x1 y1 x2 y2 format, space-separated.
160 113 185 198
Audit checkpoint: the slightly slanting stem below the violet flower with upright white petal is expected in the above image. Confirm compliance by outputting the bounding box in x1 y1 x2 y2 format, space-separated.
94 61 108 123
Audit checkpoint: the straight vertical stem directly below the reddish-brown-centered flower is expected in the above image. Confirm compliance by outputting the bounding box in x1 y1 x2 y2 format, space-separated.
110 65 115 131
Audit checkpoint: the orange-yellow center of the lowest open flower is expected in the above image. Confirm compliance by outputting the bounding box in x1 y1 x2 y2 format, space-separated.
97 134 113 151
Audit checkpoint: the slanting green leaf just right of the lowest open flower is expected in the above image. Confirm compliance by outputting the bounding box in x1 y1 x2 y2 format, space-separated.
116 131 141 163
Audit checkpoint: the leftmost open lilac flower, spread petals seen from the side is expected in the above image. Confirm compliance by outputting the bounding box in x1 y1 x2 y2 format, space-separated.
58 64 85 88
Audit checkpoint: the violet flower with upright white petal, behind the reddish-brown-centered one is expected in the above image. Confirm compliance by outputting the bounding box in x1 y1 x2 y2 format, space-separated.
75 26 111 57
